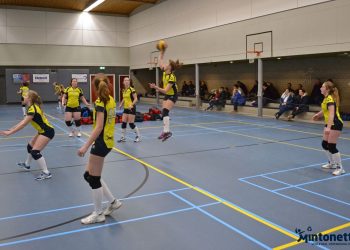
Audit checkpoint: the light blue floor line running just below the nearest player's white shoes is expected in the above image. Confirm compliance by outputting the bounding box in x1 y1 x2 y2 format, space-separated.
0 202 220 247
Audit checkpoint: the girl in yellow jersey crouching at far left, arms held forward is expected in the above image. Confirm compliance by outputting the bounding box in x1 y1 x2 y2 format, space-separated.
0 90 55 180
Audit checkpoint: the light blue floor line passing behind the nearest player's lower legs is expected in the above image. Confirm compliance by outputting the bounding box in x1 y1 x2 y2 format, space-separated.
0 187 190 221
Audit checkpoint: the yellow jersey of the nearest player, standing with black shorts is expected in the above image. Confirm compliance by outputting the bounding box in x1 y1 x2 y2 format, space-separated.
93 96 116 148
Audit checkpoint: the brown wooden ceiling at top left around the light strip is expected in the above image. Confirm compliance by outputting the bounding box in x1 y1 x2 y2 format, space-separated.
0 0 160 16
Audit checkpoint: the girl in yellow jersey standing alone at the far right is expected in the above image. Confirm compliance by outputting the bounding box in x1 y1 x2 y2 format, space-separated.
313 81 345 175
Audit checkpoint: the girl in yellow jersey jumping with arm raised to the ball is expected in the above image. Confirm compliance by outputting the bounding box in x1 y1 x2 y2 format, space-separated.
150 47 182 141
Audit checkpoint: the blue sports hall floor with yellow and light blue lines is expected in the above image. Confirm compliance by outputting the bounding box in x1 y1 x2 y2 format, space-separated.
0 104 350 250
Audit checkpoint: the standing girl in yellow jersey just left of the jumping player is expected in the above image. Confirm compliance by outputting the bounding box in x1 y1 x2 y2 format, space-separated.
118 77 141 142
